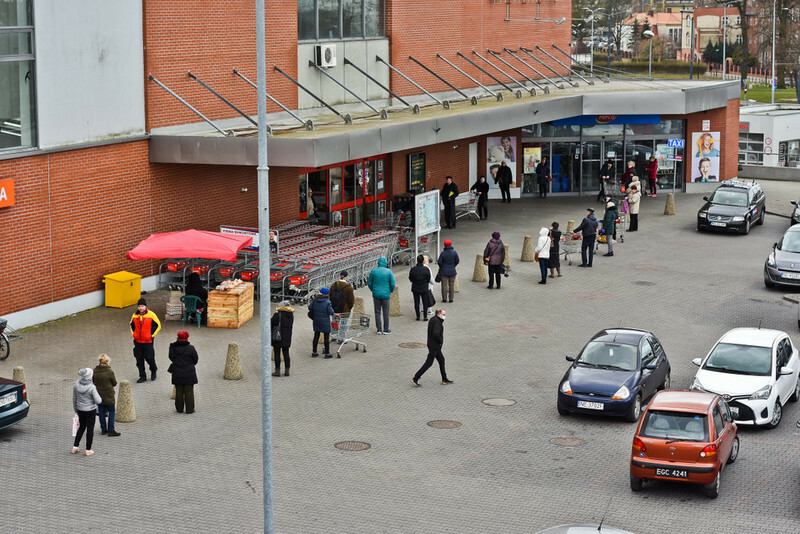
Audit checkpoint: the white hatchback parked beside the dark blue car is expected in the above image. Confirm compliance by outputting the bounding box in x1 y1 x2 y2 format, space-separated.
691 328 800 428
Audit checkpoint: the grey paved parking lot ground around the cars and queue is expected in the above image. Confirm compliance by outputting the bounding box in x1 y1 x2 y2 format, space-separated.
0 182 800 534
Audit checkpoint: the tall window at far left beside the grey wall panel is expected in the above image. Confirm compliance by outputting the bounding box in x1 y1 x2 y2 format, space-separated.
0 0 36 151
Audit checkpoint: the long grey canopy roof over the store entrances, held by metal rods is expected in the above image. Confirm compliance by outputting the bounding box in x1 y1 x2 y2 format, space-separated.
150 78 739 167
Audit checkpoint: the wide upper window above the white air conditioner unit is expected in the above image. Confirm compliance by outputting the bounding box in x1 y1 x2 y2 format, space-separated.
297 0 386 41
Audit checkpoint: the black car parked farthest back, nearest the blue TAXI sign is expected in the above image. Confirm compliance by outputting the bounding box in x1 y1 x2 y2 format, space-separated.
697 180 767 234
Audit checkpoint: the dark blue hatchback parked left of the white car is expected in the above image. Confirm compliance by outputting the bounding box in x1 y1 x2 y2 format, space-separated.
557 328 670 422
